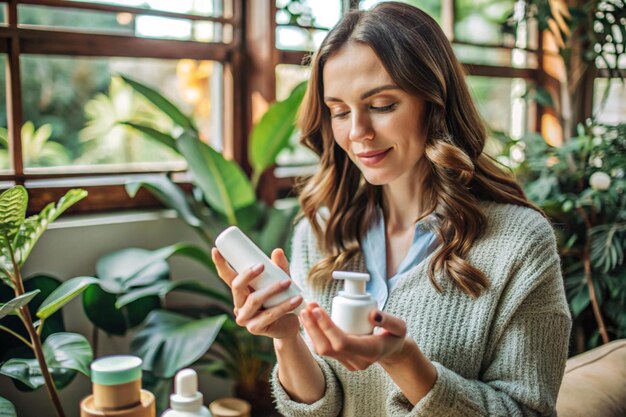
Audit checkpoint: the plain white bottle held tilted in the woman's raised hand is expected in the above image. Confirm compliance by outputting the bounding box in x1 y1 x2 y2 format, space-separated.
215 226 305 314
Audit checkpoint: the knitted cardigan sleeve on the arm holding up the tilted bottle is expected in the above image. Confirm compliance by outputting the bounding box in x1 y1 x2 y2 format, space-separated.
270 219 343 417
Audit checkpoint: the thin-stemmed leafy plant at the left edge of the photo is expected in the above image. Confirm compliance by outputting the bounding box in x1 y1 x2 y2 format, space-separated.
0 185 92 417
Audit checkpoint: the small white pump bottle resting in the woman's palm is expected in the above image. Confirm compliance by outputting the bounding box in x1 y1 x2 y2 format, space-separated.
331 271 377 334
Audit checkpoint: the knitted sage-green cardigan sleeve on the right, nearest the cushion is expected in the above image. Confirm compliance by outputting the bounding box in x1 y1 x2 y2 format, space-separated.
387 216 571 417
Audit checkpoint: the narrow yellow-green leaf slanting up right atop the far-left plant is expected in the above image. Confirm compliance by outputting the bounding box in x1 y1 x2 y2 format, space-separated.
14 189 87 266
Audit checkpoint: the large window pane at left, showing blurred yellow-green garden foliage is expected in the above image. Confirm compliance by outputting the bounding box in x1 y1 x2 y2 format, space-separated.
16 55 221 172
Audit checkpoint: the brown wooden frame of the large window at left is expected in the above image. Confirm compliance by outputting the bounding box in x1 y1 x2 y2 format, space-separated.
0 0 247 213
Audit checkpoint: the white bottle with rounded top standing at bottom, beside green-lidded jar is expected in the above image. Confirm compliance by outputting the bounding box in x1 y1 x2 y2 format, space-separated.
161 369 212 417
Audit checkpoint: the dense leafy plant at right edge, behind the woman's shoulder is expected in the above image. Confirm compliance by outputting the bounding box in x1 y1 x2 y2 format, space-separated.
502 121 626 352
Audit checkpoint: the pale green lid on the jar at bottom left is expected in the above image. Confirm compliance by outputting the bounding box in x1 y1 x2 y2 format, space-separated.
91 355 141 385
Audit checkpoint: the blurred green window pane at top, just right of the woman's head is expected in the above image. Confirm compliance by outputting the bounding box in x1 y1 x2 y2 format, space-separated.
454 0 514 44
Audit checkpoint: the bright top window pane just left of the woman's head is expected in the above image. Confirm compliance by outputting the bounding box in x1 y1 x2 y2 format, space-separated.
276 0 341 51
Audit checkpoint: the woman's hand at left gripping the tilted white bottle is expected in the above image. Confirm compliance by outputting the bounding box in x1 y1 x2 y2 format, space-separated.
211 248 303 339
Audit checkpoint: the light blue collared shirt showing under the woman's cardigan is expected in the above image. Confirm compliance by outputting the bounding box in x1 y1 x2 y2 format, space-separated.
361 207 439 310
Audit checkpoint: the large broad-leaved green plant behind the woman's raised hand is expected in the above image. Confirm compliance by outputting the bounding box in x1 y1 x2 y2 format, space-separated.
63 77 305 415
